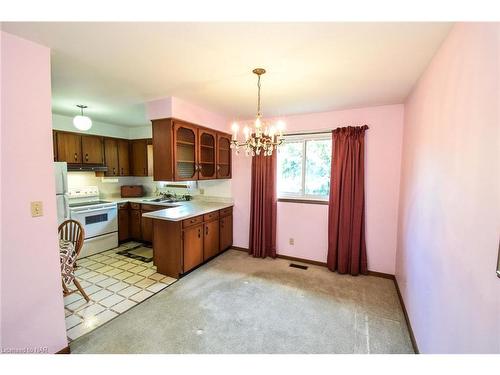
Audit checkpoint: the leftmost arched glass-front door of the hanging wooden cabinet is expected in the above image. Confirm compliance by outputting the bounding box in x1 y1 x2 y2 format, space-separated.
174 123 198 181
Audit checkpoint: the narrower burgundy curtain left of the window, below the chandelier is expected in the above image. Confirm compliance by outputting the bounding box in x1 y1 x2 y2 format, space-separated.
248 153 277 258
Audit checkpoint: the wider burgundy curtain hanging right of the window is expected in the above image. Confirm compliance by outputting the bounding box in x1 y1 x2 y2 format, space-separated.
327 125 368 275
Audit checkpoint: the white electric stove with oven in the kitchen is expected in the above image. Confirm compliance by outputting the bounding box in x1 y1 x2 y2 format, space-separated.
68 186 118 257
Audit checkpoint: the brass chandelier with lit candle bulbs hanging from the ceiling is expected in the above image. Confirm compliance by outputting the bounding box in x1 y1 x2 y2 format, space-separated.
231 68 285 156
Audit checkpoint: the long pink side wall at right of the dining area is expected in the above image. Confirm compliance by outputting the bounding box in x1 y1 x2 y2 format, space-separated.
396 23 500 353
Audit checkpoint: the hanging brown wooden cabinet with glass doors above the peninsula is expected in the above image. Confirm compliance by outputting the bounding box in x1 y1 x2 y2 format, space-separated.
152 118 231 181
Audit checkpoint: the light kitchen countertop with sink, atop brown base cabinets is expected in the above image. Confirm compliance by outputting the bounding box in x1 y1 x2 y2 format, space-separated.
107 197 234 221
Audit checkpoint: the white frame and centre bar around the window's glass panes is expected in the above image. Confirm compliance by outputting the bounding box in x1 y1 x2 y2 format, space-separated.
276 131 333 204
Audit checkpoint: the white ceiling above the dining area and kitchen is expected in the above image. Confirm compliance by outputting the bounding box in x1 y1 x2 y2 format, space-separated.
2 22 451 126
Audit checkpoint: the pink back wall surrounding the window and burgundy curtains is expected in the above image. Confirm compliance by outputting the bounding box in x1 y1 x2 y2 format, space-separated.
232 105 404 274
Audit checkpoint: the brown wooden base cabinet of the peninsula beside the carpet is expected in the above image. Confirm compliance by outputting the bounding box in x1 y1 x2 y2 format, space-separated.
152 208 233 278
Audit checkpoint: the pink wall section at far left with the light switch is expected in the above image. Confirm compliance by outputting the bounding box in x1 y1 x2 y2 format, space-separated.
0 32 67 352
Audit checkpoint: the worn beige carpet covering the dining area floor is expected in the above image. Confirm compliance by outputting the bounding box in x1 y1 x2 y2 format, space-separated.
71 250 413 353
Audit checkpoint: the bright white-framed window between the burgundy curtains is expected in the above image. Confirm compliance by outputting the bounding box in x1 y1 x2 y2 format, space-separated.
277 133 332 200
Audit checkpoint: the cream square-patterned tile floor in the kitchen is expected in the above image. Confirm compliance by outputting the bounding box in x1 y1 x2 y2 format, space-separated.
64 242 176 342
